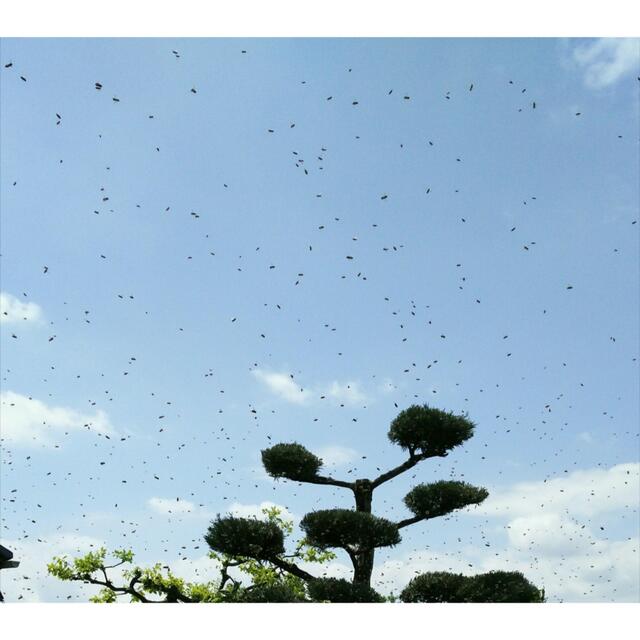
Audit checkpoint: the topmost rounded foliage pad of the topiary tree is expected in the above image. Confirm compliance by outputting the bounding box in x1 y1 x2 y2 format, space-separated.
388 404 475 456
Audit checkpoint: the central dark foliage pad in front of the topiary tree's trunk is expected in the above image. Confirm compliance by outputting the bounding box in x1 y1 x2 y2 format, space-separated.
300 509 400 551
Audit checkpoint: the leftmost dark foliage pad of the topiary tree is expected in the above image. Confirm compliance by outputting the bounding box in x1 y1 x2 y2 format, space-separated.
204 516 284 559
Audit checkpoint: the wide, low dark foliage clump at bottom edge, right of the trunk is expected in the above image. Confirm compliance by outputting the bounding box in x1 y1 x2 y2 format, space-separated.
400 571 544 603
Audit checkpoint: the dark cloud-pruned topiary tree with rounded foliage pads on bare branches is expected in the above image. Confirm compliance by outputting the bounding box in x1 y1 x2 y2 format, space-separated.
205 405 539 602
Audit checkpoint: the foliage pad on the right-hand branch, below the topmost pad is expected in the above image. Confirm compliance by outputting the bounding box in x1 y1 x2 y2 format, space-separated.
404 480 489 519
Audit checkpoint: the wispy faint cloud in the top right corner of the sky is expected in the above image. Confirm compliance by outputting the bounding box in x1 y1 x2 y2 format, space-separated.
573 38 640 89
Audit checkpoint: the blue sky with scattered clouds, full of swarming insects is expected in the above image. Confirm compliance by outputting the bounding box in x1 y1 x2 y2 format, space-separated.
0 39 640 601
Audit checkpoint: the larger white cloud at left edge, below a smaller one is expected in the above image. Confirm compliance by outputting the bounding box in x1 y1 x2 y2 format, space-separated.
0 391 114 446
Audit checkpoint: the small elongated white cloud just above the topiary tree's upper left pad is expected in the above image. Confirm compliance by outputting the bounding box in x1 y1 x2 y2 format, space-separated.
251 369 367 405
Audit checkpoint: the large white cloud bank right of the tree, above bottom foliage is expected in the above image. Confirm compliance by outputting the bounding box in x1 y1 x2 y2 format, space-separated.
373 463 640 602
